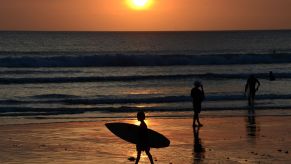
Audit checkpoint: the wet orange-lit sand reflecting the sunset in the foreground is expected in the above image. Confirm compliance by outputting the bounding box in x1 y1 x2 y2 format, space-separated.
0 116 291 164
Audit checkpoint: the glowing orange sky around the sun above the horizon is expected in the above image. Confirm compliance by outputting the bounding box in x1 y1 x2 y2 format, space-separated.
0 0 291 31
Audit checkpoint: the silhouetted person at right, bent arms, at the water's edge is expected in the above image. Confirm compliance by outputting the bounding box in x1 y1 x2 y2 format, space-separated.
245 75 261 107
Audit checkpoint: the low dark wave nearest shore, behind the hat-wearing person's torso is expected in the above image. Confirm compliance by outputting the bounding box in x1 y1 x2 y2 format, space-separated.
0 94 291 105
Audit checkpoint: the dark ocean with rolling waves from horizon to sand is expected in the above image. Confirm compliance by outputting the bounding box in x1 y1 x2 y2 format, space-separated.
0 31 291 123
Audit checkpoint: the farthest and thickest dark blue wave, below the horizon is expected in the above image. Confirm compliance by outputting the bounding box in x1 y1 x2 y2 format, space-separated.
0 52 291 67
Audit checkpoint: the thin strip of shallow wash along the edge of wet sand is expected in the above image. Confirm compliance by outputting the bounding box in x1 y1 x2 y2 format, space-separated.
0 109 291 126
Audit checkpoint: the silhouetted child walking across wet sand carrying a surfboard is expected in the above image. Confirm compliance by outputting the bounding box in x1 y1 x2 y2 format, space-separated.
135 111 154 164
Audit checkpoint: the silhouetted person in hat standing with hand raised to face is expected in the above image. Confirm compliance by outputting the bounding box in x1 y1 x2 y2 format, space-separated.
191 81 205 127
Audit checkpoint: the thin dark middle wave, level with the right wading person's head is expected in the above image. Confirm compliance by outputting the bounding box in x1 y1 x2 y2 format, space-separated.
0 73 291 84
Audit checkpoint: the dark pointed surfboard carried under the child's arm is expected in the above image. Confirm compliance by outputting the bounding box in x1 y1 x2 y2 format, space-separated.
105 123 170 148
